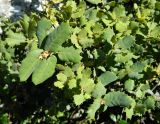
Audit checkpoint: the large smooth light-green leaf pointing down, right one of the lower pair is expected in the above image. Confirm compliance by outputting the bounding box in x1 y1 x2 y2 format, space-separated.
32 55 57 85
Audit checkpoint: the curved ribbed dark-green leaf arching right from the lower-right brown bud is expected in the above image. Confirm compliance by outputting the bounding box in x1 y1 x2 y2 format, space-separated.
103 91 135 107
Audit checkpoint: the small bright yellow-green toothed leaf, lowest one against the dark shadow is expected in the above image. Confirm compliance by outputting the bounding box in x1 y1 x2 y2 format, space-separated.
73 93 85 105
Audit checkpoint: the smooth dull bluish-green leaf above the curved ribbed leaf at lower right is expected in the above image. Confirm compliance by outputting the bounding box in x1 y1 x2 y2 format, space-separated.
98 71 118 86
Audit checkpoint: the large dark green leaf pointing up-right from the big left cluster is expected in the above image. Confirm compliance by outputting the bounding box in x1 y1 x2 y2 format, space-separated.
45 23 71 52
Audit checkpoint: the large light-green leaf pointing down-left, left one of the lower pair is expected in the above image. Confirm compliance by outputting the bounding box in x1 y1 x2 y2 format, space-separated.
19 49 43 81
